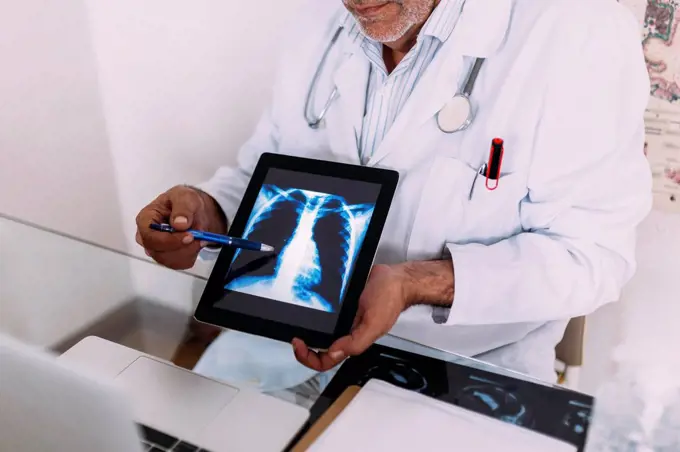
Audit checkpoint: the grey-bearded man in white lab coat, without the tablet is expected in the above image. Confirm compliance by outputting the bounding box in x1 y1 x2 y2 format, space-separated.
138 0 651 384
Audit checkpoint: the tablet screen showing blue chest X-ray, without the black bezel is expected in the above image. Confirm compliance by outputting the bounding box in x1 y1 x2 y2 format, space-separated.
215 168 381 332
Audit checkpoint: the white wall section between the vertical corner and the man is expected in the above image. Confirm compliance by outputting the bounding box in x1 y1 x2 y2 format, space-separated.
82 0 299 264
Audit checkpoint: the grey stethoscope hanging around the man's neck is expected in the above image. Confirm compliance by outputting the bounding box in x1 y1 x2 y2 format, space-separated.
304 27 484 133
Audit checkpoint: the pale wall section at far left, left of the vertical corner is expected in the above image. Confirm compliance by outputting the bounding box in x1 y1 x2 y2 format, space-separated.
0 0 126 247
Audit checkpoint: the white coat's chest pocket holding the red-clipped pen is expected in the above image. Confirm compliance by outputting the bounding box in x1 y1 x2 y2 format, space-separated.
454 169 528 245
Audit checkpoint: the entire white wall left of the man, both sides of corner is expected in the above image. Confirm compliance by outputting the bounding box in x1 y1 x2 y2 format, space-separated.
0 0 301 260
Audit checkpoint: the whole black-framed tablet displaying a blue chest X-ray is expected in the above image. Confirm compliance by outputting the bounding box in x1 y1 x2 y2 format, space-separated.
195 153 399 349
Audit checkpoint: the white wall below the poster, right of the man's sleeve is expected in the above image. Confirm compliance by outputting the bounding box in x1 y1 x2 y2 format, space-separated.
579 211 680 393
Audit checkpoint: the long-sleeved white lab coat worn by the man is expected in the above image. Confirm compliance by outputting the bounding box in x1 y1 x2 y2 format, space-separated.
197 0 651 380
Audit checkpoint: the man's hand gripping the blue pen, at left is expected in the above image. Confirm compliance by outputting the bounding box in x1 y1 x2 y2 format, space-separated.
136 186 228 270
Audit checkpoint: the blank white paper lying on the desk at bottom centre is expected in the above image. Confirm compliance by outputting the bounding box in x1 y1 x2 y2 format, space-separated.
309 380 577 452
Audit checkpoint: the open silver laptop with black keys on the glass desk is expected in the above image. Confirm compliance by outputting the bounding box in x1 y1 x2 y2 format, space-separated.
0 335 309 452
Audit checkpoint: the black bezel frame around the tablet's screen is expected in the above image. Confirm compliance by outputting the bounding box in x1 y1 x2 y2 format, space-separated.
194 153 399 349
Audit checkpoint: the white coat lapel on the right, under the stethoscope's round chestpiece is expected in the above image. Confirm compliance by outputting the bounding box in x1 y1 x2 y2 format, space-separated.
368 0 513 166
